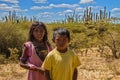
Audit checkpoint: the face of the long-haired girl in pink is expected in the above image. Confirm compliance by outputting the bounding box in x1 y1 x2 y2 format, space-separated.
33 27 45 42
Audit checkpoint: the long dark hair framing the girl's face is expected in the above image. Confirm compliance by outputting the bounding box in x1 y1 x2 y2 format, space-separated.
28 21 48 42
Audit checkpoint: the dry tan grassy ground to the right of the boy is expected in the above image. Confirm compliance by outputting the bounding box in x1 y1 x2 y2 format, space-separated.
78 49 120 80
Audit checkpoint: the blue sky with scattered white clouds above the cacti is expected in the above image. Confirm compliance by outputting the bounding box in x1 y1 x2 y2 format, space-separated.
0 0 120 22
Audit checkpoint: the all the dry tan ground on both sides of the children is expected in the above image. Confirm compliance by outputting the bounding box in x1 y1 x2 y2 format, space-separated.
0 47 120 80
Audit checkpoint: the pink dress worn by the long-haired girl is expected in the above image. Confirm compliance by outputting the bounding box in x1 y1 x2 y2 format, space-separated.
24 42 51 80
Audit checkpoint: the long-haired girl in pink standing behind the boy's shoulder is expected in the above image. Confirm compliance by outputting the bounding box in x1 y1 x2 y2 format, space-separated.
20 21 52 80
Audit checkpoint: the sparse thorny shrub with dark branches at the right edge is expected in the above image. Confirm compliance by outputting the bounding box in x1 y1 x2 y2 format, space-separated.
98 31 120 58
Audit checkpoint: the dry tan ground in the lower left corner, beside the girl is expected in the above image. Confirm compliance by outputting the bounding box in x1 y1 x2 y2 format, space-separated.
0 64 27 80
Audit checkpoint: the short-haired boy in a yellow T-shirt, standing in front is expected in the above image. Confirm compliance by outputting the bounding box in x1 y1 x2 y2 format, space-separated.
42 28 80 80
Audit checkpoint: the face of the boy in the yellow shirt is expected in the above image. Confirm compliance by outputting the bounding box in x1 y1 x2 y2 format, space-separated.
54 34 70 50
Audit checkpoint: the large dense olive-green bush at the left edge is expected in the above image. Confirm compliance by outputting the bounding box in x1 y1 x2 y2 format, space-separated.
0 23 26 58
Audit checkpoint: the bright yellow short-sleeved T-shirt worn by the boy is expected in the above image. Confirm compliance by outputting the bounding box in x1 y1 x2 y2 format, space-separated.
42 48 80 80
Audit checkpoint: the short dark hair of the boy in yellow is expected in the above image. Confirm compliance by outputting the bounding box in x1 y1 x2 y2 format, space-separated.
53 28 70 40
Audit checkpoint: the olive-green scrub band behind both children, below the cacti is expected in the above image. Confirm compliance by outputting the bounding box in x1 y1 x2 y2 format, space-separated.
0 22 120 61
